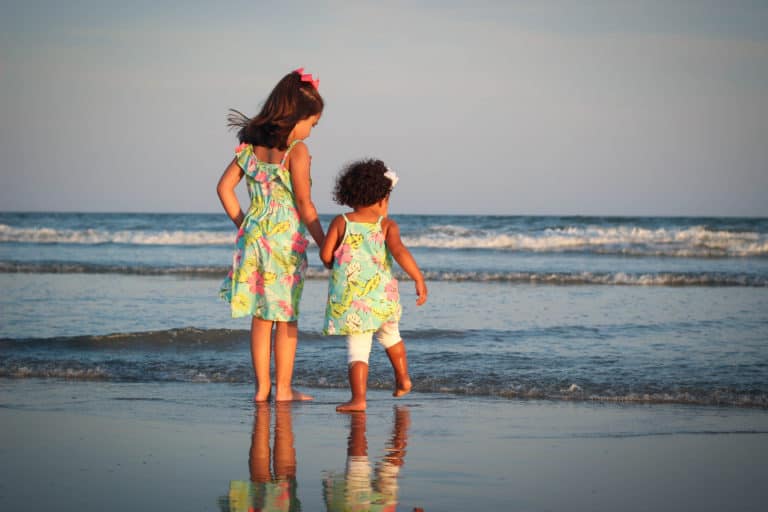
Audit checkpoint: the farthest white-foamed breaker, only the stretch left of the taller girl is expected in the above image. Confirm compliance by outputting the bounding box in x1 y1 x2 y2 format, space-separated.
0 224 235 246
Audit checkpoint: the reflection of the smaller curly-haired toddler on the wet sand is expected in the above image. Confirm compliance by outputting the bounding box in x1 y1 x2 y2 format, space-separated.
323 407 411 512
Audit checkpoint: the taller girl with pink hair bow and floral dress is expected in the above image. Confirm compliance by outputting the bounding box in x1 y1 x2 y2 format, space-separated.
217 68 324 402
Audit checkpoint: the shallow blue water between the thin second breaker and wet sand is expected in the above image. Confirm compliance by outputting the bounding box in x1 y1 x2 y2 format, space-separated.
0 274 768 407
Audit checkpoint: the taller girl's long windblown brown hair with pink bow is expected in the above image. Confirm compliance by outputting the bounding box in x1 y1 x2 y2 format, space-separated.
227 71 324 149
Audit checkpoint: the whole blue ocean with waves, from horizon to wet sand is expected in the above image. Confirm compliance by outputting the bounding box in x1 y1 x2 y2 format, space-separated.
0 213 768 408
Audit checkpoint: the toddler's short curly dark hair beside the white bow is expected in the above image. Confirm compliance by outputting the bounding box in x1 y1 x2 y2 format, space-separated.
333 158 392 208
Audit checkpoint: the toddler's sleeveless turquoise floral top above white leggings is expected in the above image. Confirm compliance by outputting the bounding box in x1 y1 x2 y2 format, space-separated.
323 215 401 334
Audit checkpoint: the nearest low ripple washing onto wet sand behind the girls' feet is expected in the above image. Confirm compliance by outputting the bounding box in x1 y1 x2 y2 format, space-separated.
0 359 768 409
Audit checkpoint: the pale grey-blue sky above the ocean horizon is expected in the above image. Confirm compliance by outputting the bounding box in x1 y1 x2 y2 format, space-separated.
0 0 768 216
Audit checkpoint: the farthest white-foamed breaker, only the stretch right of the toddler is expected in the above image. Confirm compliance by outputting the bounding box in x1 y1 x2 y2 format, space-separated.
403 225 768 258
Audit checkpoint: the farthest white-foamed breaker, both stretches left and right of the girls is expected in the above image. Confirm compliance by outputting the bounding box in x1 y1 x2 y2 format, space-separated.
0 224 768 258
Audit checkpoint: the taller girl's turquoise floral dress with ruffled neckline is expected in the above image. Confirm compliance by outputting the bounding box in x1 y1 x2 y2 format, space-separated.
219 140 309 322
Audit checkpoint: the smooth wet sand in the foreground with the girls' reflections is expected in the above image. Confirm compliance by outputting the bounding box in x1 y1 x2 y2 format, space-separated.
0 380 768 511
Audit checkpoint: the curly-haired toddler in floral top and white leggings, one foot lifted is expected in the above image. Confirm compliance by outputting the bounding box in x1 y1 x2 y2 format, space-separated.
320 160 427 412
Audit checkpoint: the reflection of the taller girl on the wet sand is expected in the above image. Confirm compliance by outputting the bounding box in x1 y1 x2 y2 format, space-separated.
221 402 301 512
